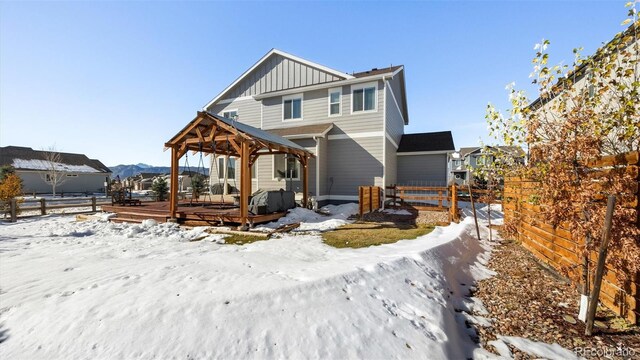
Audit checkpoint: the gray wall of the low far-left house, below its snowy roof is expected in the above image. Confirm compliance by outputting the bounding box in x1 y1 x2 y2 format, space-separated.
16 170 110 194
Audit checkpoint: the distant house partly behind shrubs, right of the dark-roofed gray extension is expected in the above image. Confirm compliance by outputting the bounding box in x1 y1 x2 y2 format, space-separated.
449 146 526 185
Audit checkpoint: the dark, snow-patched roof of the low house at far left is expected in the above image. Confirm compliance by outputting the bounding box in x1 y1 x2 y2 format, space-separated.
0 146 111 173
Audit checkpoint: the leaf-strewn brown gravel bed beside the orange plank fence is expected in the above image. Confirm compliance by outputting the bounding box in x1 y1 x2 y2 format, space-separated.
473 241 640 359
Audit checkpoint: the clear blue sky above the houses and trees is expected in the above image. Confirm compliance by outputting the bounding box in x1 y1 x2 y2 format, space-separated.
0 1 626 166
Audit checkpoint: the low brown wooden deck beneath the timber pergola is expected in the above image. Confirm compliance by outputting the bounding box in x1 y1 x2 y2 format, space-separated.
102 201 287 226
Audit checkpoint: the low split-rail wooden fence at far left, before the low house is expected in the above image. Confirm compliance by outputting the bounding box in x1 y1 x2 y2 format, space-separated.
3 196 111 222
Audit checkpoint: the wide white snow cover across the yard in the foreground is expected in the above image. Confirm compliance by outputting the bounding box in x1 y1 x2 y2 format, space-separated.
0 207 564 359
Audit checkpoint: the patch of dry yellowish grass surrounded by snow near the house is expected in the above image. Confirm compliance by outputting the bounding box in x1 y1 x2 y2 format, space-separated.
322 222 434 249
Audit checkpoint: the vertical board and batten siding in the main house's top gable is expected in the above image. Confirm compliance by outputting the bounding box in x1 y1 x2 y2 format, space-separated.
224 54 342 99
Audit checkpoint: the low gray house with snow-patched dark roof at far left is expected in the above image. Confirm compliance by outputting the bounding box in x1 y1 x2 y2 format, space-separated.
0 146 111 194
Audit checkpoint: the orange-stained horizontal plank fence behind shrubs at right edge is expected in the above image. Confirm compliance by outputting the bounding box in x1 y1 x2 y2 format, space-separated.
503 152 640 323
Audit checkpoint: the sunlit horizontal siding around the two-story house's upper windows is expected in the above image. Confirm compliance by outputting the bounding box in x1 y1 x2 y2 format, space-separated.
262 81 384 135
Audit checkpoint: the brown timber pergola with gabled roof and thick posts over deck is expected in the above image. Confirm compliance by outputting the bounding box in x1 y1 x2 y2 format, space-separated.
164 111 315 227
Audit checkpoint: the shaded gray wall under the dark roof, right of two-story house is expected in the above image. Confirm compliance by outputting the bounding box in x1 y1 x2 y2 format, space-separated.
398 154 447 186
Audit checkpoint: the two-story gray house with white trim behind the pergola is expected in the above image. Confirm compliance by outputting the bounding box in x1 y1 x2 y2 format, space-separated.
203 49 447 204
